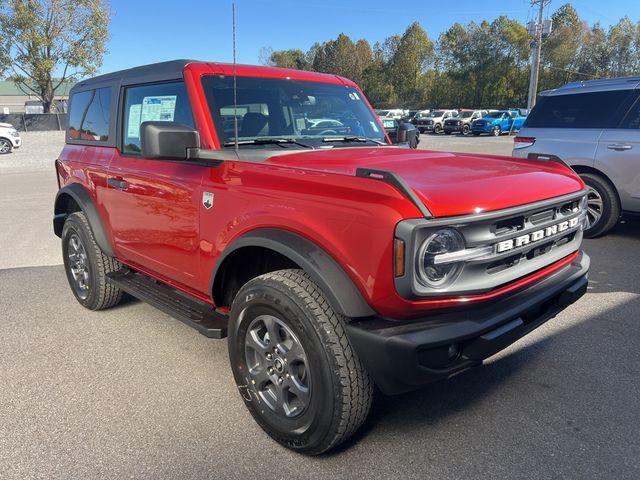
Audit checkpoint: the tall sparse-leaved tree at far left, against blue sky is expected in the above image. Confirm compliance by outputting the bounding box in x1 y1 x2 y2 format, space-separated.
0 0 111 112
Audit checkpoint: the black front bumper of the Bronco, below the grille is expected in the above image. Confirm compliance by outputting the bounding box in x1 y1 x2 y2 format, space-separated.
347 252 589 394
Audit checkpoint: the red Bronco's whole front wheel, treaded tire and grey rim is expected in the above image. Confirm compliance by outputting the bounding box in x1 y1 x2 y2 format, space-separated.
229 270 373 455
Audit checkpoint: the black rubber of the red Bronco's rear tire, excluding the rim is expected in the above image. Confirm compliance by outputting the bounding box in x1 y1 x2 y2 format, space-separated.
62 212 122 310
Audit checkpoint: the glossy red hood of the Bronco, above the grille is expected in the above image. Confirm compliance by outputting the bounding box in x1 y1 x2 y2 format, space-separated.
267 147 584 217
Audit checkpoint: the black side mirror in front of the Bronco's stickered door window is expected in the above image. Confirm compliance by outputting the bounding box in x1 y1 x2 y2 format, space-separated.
140 122 200 160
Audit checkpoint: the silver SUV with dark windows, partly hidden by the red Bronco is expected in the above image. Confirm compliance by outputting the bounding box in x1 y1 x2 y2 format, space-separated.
513 77 640 237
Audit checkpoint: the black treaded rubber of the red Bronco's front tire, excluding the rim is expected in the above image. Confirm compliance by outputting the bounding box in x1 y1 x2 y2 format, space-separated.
229 269 373 455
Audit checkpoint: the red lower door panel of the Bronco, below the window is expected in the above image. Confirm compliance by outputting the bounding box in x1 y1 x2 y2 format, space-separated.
103 155 206 288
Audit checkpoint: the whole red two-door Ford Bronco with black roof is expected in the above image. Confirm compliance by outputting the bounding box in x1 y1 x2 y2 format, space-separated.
53 61 589 454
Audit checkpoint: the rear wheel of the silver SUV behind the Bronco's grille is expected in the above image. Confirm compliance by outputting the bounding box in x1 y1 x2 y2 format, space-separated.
580 173 620 238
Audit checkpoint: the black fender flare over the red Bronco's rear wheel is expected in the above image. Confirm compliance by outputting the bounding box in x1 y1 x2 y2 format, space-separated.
53 183 115 257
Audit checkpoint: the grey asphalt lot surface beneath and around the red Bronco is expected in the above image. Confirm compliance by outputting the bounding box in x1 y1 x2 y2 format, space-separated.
0 134 640 480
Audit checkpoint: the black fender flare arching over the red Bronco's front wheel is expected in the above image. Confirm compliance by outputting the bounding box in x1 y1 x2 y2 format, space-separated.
209 228 375 318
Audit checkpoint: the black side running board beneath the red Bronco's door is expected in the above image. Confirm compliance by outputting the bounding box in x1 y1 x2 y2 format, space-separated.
108 270 227 338
